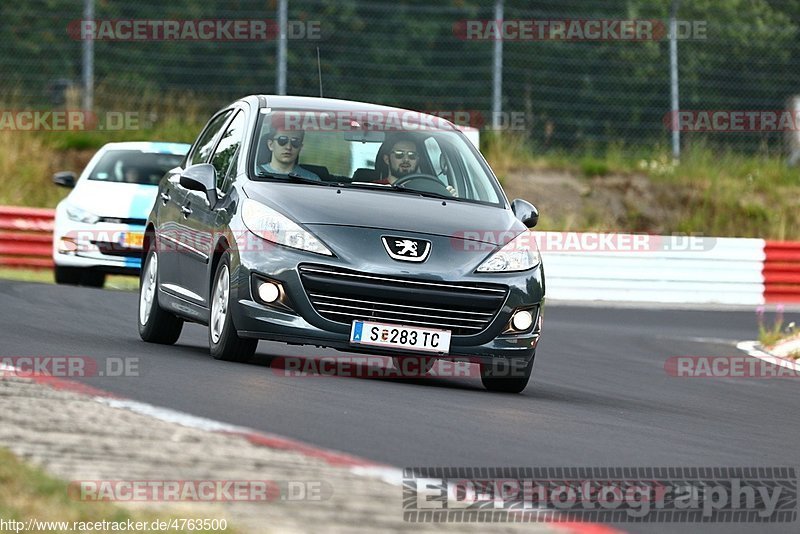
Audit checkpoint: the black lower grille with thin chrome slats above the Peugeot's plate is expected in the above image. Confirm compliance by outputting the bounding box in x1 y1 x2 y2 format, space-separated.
299 265 508 336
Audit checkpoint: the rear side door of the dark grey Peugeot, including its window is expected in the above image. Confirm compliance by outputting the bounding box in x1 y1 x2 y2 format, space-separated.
158 109 232 305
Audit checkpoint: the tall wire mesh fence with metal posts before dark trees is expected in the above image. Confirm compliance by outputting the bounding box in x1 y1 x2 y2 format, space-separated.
0 0 800 152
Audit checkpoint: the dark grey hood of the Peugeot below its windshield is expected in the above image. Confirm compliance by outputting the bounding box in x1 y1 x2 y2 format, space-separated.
244 182 526 245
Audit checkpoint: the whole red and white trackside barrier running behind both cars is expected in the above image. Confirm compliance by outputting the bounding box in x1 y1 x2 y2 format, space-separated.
0 206 800 305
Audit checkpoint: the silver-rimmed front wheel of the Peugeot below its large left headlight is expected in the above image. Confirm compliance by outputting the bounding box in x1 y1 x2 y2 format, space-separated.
208 252 258 362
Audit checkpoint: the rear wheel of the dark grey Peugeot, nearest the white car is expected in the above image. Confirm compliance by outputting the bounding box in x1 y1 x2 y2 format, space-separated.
138 248 183 345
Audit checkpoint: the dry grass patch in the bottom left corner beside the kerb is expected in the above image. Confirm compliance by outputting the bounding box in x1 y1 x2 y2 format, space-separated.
0 448 236 534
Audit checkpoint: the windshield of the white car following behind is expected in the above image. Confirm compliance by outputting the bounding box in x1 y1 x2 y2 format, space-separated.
89 150 183 185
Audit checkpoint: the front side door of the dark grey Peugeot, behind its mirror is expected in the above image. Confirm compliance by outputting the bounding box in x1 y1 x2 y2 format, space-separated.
183 110 247 304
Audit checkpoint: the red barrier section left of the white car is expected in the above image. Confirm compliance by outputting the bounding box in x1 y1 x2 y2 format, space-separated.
0 206 55 268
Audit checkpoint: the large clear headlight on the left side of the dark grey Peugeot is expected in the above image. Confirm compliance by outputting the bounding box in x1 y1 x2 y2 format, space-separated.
242 198 333 256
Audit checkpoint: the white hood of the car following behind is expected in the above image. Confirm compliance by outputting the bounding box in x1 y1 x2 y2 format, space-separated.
67 180 158 219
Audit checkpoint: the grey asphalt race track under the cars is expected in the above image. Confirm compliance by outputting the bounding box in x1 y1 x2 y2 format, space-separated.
0 281 800 532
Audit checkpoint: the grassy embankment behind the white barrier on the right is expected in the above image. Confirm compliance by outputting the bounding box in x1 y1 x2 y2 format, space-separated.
481 132 800 240
